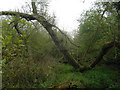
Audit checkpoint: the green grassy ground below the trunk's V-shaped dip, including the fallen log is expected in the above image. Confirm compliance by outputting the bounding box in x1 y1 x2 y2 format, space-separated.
40 64 120 88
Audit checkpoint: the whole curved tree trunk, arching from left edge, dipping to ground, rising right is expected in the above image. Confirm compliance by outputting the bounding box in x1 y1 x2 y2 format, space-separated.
0 10 120 71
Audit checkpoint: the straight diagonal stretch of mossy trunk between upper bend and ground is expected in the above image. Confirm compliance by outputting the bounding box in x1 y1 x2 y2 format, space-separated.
33 14 83 71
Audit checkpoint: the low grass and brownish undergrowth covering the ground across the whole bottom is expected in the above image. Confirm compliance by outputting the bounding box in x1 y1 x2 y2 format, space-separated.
3 57 120 88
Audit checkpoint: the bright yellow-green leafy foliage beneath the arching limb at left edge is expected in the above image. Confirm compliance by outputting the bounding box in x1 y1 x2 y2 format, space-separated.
2 17 30 63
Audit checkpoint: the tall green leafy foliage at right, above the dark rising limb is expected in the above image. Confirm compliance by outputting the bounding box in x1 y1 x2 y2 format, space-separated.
74 2 120 63
